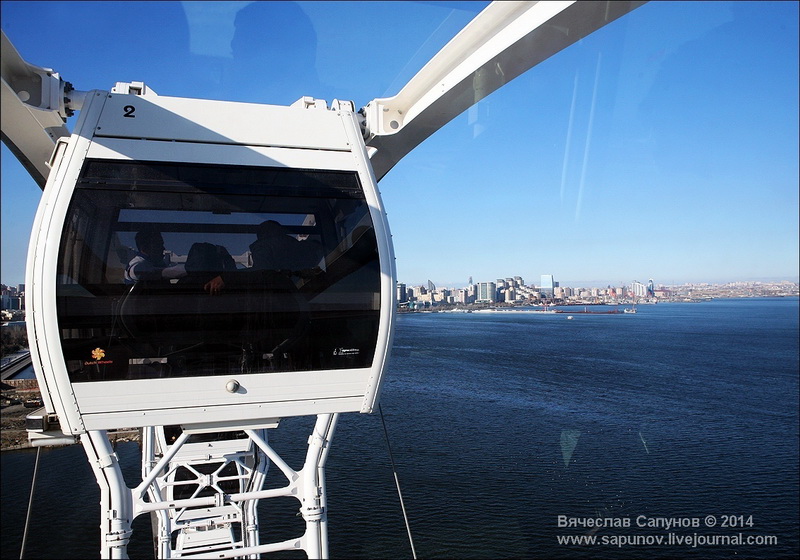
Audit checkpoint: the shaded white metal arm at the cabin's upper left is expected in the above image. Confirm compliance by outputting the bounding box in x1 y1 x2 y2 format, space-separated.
0 32 70 188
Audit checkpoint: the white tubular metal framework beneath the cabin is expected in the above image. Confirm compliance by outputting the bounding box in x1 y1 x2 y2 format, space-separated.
81 414 338 558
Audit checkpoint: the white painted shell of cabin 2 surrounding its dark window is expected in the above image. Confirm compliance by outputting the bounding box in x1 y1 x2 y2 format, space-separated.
28 92 395 434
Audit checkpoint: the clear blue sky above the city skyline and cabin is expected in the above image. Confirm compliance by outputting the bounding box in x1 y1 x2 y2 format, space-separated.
0 2 800 287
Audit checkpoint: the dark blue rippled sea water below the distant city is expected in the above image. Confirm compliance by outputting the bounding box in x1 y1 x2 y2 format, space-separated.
2 298 800 558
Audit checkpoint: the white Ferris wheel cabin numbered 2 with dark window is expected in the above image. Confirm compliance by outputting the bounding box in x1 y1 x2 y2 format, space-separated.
28 86 395 434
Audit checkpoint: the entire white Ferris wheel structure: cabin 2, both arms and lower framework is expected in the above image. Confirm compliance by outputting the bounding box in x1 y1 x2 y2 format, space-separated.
2 2 641 558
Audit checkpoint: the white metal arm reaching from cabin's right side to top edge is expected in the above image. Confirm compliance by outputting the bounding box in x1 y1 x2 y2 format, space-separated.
362 1 644 179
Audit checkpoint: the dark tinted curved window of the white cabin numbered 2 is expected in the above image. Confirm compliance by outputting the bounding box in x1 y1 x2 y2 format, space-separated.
57 160 380 382
